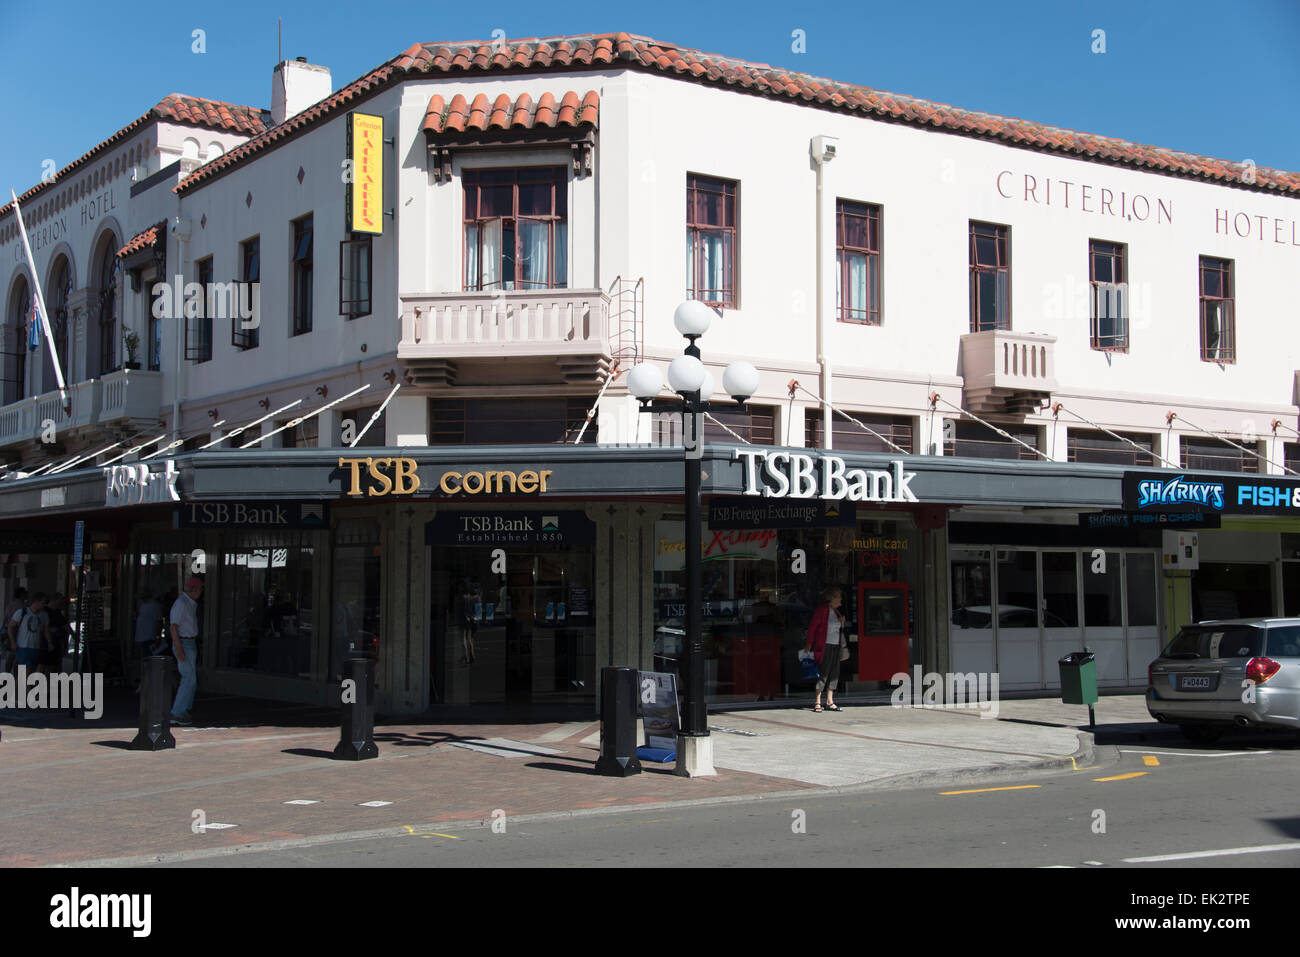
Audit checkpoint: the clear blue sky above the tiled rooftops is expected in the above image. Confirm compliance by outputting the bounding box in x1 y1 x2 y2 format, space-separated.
0 0 1300 192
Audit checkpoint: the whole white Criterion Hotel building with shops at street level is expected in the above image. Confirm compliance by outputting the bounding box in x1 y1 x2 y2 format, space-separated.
0 34 1300 714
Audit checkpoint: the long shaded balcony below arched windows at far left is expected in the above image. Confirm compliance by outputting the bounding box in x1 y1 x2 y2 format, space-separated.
0 369 163 447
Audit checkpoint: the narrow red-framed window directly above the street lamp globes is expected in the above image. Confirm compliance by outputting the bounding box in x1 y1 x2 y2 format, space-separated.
686 173 740 308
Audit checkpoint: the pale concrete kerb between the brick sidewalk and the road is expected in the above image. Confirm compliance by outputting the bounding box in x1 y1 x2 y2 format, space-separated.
55 731 1102 869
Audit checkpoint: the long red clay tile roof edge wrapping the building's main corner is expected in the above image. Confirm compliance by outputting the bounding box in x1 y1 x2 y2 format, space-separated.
174 33 1300 195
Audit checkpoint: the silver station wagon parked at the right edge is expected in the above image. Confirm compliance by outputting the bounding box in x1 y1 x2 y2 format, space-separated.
1147 618 1300 745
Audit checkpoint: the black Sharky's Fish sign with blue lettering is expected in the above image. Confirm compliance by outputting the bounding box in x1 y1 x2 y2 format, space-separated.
1123 472 1300 515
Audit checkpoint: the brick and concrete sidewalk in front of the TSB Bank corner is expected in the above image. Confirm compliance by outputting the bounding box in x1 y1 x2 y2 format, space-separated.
0 694 1173 867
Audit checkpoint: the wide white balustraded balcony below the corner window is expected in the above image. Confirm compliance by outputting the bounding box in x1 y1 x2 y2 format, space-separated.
398 289 611 387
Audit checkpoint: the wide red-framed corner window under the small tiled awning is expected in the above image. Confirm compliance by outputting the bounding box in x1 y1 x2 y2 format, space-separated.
467 166 568 291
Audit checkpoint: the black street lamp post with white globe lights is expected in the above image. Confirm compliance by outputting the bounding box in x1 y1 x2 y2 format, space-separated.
628 299 758 778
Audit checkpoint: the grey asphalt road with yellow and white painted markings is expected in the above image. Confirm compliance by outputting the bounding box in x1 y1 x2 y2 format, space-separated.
169 736 1300 869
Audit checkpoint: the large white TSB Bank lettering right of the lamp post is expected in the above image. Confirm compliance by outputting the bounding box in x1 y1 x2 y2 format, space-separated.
735 449 920 502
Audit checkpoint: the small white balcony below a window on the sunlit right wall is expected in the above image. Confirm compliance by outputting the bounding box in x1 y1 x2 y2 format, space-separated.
961 329 1057 415
